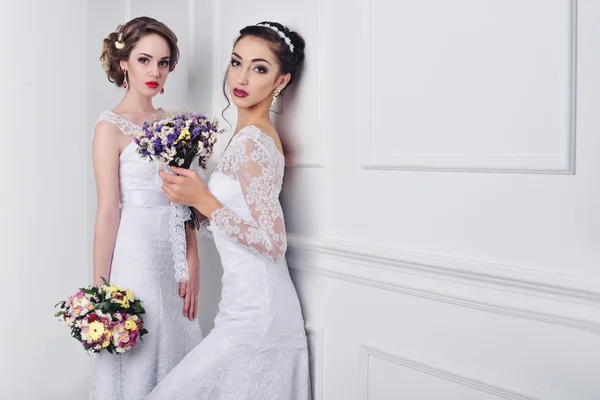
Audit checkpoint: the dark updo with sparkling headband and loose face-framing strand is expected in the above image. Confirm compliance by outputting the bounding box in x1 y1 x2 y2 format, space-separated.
223 21 305 113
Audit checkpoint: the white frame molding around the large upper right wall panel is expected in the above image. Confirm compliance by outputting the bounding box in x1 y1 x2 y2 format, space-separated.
360 0 578 174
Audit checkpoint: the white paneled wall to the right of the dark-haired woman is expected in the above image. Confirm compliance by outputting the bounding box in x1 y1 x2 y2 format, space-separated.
284 0 600 400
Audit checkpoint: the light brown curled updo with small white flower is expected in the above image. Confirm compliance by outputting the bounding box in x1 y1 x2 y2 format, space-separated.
100 17 179 87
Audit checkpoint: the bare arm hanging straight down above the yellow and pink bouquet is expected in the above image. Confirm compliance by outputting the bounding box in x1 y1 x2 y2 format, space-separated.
92 121 123 286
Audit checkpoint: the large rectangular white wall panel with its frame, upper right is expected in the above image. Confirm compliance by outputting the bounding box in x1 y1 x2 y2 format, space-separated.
362 0 577 174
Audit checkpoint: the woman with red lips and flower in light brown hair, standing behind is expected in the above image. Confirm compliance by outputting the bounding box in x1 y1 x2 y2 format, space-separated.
90 17 202 400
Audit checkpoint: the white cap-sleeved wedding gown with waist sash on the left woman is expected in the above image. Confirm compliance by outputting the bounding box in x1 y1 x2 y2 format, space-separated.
90 111 202 400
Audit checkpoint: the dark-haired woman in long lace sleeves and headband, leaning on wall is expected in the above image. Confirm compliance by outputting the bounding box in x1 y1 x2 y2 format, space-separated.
147 23 310 400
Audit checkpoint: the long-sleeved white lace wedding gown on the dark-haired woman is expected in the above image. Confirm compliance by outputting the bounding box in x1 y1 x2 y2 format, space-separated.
147 126 310 400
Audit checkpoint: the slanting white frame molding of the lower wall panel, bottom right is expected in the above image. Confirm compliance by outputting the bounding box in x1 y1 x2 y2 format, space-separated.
360 345 559 400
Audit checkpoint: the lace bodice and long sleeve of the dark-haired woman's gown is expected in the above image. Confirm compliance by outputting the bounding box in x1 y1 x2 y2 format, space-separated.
210 126 287 262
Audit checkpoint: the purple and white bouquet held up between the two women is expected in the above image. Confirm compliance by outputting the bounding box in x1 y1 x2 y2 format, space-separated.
134 112 222 229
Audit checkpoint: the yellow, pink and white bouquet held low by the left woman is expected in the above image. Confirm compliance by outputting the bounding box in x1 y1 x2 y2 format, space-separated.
54 281 148 354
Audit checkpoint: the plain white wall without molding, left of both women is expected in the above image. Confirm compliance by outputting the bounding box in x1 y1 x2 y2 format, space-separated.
0 0 89 400
